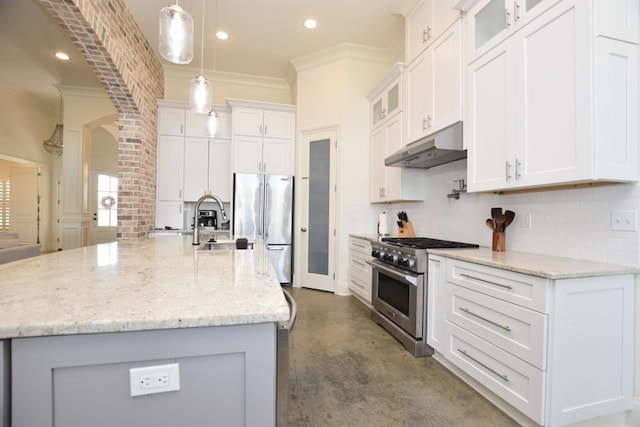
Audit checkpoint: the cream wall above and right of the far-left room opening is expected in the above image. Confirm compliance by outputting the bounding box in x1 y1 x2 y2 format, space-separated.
0 86 59 250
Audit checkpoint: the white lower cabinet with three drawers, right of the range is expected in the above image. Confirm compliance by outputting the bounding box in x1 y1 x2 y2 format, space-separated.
427 255 634 426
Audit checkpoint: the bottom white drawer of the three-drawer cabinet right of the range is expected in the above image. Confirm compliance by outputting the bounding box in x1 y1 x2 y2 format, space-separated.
446 322 545 425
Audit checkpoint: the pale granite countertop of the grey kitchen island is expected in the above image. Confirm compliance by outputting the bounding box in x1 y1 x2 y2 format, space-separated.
0 236 289 338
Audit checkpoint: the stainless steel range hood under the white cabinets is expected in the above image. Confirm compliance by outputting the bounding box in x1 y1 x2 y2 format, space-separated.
384 122 467 169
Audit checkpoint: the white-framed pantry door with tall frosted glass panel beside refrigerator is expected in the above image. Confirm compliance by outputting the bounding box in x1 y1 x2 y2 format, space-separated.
296 129 337 292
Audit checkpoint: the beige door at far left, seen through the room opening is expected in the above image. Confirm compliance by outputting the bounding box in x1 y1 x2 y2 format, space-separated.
9 166 40 243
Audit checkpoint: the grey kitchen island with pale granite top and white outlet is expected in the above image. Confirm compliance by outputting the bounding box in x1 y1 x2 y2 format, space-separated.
0 236 289 427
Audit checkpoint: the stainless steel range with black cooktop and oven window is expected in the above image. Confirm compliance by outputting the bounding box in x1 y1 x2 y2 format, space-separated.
369 238 478 357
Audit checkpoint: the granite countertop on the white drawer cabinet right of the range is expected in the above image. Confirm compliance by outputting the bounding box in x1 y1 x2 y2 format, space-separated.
427 247 640 279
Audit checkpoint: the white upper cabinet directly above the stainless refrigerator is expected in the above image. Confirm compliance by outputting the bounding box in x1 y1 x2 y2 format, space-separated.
228 100 295 175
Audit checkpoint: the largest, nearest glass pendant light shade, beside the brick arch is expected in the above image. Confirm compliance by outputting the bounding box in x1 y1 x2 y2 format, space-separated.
158 0 193 64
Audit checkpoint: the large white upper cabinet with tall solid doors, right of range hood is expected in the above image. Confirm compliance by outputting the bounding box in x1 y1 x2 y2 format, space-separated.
465 0 638 191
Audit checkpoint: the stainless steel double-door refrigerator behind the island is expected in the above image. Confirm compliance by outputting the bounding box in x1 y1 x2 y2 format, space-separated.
232 173 293 283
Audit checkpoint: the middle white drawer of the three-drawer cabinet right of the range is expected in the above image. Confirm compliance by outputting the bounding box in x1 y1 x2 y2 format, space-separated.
445 283 547 370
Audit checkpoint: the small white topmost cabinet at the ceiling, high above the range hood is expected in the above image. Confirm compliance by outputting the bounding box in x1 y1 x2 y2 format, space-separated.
405 0 460 64
